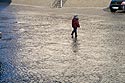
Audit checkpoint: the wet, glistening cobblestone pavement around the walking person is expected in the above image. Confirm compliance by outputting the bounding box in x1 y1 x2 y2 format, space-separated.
0 5 125 83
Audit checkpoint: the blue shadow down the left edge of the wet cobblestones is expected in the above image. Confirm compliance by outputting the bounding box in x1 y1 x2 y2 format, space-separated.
0 0 19 83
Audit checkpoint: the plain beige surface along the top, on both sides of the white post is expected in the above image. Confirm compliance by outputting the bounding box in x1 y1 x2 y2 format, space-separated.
12 0 111 7
